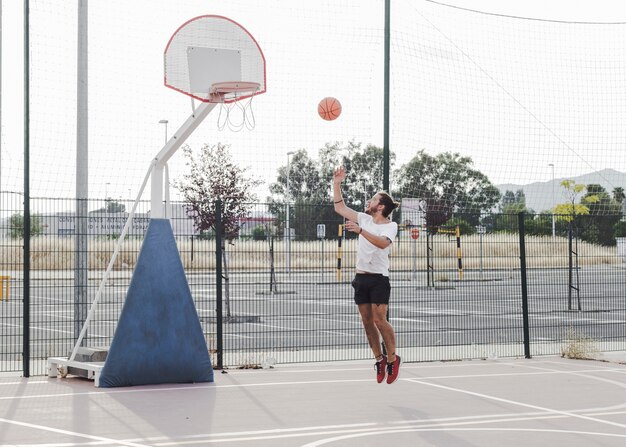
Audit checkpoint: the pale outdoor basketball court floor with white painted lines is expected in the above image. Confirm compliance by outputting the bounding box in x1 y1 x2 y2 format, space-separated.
0 357 626 447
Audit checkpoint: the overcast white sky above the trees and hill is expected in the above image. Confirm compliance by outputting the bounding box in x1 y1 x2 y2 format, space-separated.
0 0 626 211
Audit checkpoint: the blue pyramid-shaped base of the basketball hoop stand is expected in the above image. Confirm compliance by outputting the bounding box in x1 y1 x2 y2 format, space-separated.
100 219 213 387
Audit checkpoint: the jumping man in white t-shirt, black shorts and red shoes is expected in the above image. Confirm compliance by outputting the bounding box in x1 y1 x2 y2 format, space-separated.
333 166 401 383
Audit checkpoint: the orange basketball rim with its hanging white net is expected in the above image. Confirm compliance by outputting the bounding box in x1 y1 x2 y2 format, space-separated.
209 81 261 132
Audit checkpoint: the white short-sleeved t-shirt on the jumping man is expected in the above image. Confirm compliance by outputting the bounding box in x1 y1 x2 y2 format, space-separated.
356 213 398 276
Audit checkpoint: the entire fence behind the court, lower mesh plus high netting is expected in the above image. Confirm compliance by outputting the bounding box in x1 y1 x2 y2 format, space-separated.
0 0 626 372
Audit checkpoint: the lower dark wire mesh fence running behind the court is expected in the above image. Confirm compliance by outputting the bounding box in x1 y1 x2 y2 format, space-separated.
0 193 626 375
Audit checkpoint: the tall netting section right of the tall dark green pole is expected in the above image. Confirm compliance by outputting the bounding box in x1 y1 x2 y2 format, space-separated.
391 2 626 214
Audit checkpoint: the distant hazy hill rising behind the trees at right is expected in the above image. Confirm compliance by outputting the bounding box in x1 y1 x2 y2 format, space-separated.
496 169 626 213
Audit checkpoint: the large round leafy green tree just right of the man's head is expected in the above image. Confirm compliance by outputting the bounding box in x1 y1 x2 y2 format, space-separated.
395 150 500 225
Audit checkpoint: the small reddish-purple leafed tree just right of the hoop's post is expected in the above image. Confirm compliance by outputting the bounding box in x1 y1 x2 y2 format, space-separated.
174 143 261 240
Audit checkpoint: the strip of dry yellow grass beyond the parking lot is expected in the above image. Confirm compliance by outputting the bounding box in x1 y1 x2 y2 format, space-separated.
0 234 622 271
